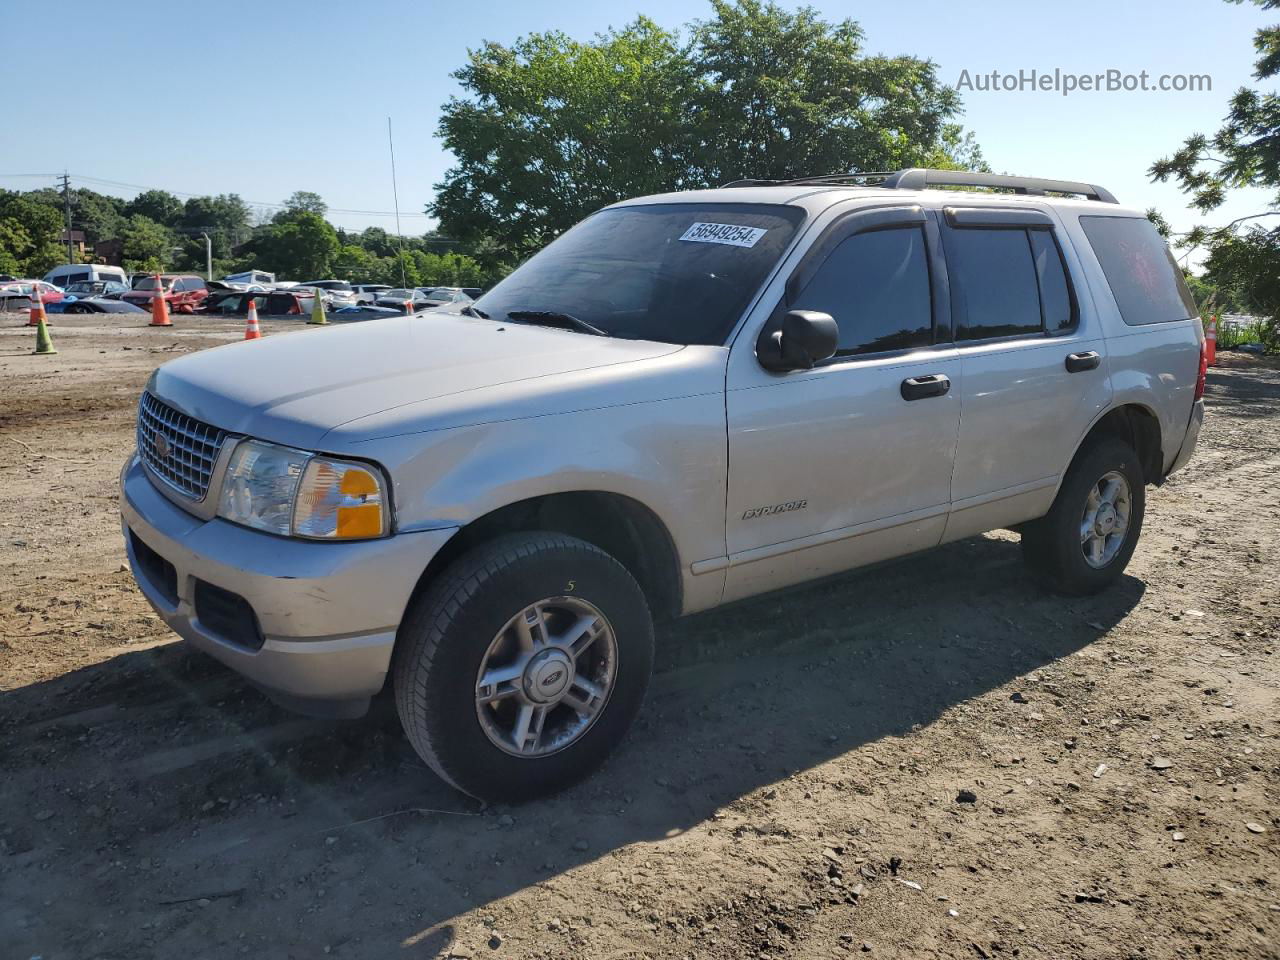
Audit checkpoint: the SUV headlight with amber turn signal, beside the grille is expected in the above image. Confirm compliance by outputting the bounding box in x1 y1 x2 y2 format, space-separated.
218 440 390 540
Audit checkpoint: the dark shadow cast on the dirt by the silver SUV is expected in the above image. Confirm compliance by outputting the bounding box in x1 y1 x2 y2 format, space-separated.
0 535 1144 956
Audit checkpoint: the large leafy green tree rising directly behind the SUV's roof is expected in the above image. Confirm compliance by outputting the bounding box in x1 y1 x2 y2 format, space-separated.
429 0 982 259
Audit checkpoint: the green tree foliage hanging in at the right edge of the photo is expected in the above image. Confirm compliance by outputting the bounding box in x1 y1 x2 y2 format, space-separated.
1151 0 1280 349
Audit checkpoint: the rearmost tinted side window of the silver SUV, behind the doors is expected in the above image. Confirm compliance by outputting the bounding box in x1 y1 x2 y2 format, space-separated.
1080 216 1199 326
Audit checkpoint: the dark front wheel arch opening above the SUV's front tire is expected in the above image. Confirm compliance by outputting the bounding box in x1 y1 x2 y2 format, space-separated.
410 490 684 620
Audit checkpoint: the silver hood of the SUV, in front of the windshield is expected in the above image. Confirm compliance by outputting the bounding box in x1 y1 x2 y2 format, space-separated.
147 314 682 449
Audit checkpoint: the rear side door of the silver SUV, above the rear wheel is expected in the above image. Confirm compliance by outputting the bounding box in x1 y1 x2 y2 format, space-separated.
942 205 1111 540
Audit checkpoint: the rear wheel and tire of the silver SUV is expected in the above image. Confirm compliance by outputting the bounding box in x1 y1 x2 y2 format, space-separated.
1023 436 1147 596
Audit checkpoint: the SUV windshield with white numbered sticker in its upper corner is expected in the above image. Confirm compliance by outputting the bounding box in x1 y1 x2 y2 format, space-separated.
476 204 804 346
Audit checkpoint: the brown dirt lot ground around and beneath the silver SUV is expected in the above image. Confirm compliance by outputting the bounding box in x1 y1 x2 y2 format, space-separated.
0 317 1280 960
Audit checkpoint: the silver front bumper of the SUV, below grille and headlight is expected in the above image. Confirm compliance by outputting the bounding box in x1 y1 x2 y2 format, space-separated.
120 456 454 714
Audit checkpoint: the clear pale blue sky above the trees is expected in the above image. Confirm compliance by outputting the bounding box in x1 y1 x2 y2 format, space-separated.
0 0 1280 264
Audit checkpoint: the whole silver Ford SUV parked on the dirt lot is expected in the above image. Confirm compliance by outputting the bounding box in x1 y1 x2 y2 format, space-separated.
120 170 1204 799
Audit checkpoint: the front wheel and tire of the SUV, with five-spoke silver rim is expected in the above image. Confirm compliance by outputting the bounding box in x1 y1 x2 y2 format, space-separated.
394 532 653 801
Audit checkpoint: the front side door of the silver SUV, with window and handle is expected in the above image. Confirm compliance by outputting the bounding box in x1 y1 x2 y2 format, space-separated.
724 206 960 600
